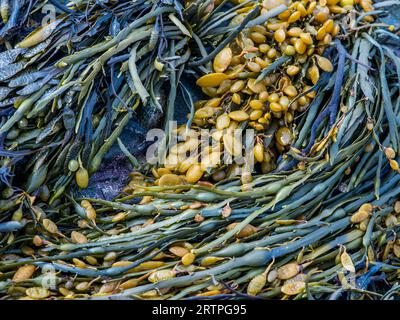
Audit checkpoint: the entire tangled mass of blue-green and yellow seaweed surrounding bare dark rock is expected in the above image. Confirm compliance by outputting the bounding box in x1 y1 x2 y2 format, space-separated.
0 0 400 299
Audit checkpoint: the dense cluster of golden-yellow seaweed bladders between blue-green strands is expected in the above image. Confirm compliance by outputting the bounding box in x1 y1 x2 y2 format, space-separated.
155 1 352 184
